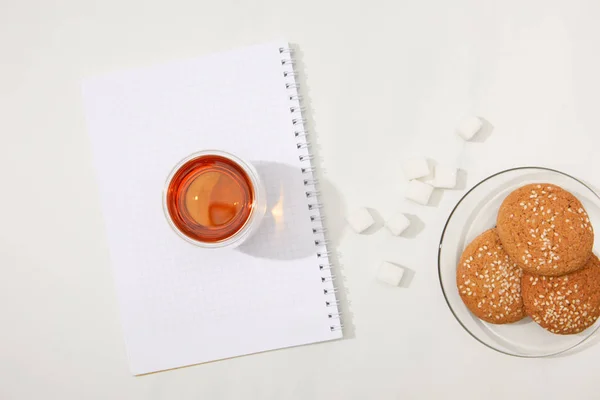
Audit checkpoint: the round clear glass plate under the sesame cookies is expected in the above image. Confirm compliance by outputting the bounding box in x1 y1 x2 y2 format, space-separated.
438 167 600 357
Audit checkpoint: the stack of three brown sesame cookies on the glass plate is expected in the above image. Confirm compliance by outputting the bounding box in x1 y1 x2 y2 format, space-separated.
456 183 600 335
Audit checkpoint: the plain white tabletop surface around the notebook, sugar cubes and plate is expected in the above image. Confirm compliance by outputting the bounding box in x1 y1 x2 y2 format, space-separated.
0 0 600 400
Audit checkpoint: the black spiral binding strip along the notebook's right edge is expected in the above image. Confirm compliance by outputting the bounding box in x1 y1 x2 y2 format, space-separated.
279 47 343 332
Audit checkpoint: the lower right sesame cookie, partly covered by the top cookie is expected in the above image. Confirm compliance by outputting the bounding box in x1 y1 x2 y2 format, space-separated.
522 255 600 335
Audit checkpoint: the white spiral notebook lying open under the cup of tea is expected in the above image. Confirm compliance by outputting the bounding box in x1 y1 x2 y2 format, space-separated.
83 43 342 375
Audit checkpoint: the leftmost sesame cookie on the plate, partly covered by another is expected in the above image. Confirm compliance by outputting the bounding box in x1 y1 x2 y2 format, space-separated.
456 229 525 324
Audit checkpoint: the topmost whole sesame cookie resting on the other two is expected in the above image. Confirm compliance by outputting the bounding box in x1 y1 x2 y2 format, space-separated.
496 183 594 276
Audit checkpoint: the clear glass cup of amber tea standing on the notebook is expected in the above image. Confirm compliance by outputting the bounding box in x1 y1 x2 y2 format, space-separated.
163 150 266 248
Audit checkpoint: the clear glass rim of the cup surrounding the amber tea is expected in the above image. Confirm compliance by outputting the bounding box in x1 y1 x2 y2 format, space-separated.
162 150 266 249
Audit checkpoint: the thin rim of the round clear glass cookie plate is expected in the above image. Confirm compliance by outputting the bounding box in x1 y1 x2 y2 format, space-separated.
437 166 600 358
